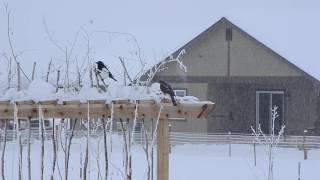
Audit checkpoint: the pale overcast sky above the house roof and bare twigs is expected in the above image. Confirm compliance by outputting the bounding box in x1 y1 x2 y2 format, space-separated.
0 0 320 79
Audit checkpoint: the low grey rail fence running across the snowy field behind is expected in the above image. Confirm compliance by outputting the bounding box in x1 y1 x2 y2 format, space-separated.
0 129 320 149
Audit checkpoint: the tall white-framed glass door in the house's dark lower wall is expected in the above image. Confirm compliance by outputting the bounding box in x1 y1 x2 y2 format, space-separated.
256 91 284 134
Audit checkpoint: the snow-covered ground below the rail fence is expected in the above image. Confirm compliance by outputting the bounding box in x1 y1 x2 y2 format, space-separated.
1 135 320 180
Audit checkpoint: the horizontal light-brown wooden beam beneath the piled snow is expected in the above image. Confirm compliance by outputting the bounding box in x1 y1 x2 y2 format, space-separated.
0 100 215 119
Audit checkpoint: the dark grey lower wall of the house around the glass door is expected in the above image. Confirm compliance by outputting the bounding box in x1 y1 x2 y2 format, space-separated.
156 76 320 134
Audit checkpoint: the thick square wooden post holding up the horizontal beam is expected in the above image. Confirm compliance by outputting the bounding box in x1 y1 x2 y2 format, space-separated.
157 118 169 180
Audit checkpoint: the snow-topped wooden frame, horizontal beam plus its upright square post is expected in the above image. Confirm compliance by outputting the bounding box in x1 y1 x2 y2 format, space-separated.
0 100 215 180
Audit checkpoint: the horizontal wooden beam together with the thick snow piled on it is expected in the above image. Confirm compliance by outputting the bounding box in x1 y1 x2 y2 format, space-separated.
0 79 215 119
